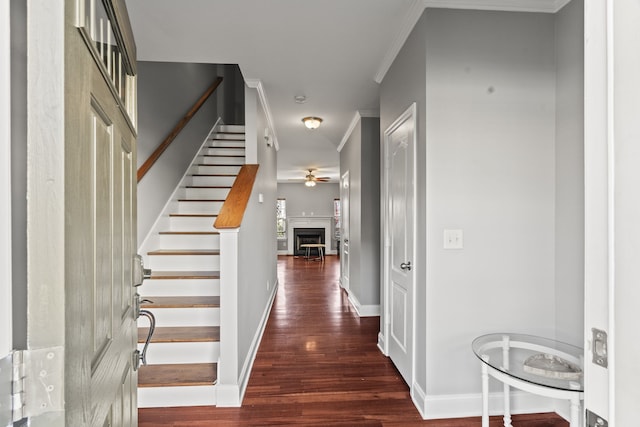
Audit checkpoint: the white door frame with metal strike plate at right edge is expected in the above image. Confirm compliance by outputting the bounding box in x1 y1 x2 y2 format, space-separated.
584 0 640 426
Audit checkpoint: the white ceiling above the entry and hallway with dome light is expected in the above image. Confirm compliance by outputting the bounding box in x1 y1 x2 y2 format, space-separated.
127 0 416 181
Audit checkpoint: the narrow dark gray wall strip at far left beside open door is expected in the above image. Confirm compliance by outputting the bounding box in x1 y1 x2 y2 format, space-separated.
10 0 27 349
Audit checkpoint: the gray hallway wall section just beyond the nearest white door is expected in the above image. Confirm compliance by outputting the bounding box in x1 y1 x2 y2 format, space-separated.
340 117 380 305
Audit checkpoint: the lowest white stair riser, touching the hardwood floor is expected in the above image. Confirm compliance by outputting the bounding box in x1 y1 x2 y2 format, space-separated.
138 385 217 408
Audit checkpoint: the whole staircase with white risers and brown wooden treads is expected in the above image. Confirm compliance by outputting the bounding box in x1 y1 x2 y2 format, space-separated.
138 125 245 408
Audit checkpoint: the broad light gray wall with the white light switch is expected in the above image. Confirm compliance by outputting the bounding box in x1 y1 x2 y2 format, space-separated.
418 10 555 395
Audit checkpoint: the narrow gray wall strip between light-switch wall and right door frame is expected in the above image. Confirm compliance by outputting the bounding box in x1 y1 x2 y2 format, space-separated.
555 0 584 347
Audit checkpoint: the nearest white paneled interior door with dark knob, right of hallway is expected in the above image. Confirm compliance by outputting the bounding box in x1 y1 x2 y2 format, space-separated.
384 104 415 386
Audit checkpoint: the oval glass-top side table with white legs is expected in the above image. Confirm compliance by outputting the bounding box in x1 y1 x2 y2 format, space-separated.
471 333 584 427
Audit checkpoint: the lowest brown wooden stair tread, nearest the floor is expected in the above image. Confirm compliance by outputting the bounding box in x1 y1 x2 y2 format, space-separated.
138 363 217 387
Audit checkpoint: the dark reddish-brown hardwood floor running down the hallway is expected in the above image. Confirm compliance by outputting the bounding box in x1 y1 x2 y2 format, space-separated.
139 256 569 427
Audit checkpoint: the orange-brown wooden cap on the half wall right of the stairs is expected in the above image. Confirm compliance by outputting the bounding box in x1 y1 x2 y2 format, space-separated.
213 165 260 230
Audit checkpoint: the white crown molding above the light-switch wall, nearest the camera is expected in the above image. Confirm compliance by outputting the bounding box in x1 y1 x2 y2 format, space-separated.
374 0 571 84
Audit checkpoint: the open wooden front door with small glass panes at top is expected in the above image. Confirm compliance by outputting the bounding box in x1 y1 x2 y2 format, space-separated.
28 0 137 427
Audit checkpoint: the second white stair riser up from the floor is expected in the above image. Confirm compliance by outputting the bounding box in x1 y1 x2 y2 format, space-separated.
138 342 220 365
